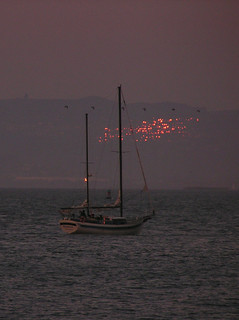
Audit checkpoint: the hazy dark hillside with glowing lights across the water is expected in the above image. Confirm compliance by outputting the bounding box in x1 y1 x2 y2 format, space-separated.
0 97 239 188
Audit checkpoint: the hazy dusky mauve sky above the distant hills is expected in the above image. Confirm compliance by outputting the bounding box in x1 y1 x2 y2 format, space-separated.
0 0 239 109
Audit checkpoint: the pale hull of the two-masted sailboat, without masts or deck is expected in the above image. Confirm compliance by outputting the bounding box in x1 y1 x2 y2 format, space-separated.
60 218 144 235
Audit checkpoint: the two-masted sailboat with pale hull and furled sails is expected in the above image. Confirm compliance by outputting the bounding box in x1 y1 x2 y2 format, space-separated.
59 86 154 235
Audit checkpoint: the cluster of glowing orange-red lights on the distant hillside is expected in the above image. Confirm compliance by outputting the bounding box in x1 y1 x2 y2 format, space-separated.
99 117 199 142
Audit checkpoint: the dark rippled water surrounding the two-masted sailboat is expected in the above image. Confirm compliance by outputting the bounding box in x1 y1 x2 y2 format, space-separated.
0 190 239 320
